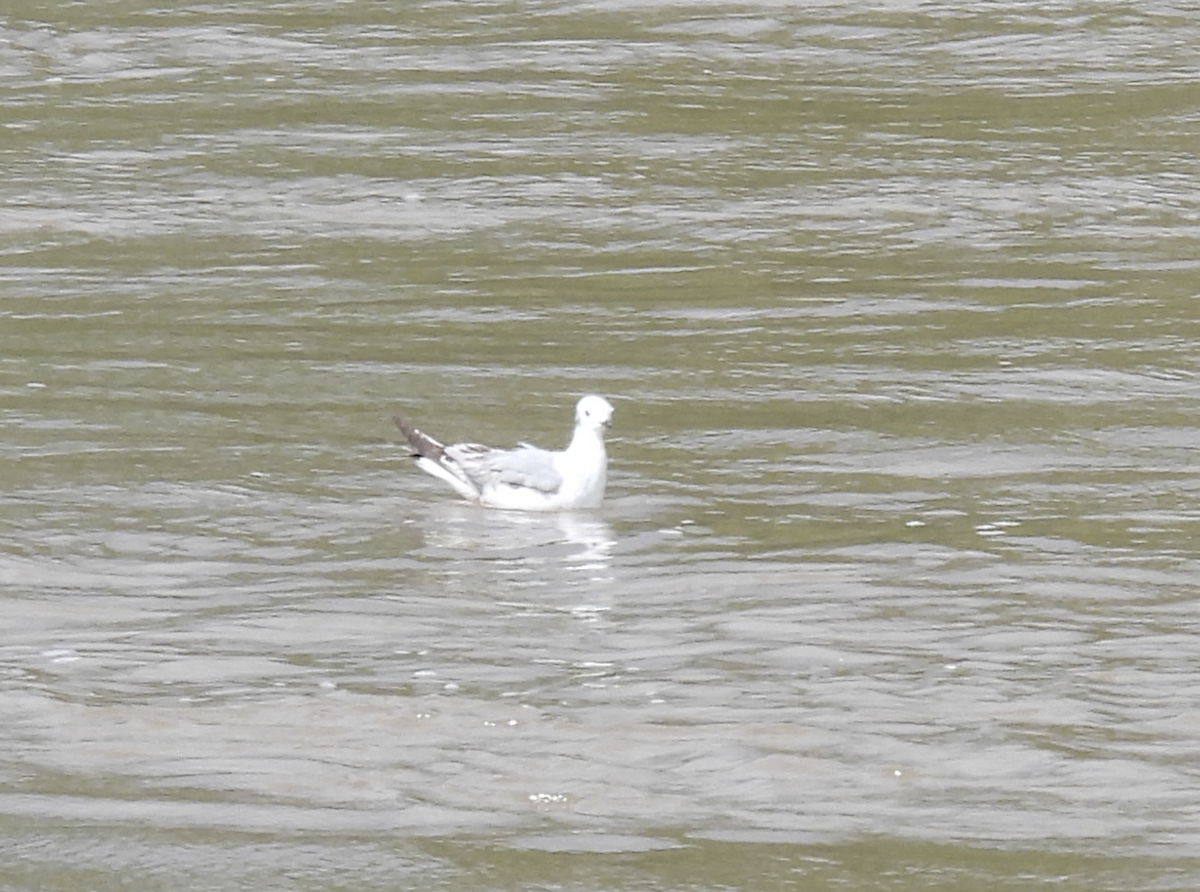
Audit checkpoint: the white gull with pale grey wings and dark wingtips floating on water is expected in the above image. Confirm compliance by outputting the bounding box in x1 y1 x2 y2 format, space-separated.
391 395 612 511
